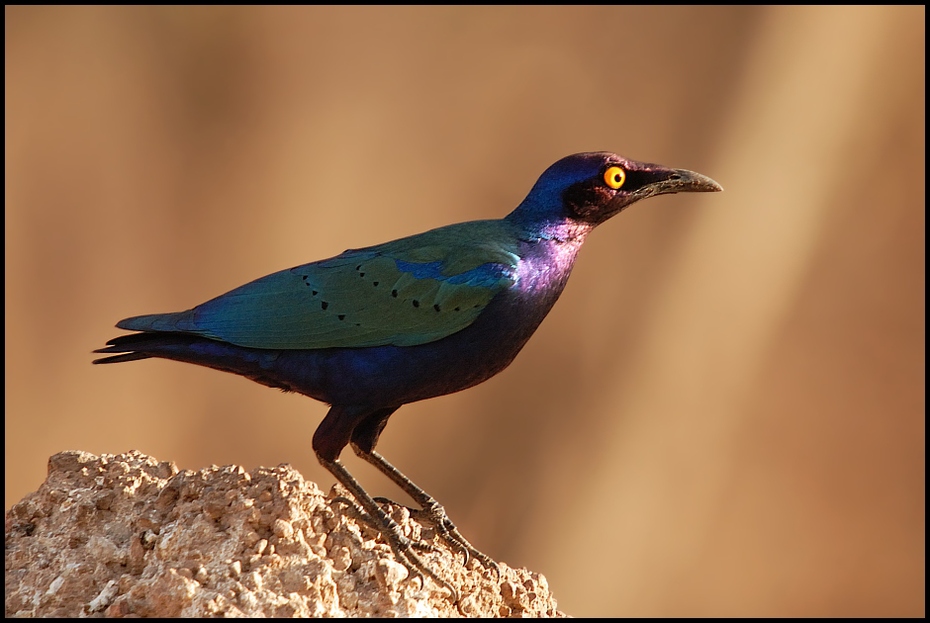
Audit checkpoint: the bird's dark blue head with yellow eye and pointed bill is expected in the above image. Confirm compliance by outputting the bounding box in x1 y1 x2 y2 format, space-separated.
507 151 723 233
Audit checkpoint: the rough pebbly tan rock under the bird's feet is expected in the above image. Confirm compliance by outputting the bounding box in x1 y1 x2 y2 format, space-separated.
5 452 563 617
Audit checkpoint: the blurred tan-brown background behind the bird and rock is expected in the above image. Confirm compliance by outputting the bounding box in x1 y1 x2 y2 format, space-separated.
5 7 925 616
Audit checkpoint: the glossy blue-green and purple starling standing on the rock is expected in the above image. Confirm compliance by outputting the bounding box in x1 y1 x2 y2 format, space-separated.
93 152 723 601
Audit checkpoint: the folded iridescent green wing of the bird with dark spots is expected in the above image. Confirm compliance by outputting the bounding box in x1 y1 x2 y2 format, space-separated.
117 221 519 349
